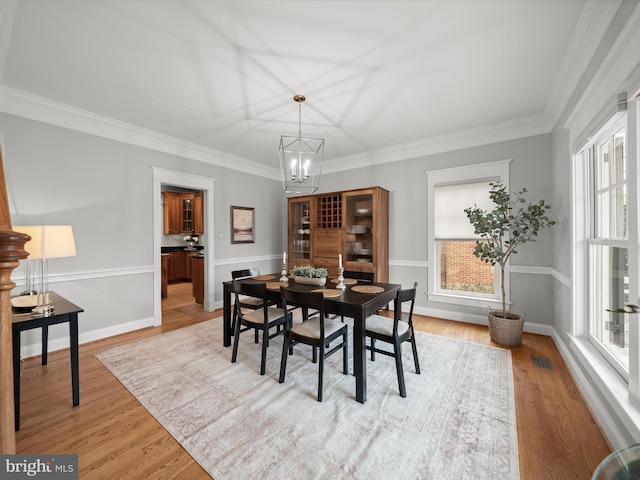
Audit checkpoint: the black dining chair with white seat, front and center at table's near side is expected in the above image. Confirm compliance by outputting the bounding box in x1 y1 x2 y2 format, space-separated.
279 286 349 402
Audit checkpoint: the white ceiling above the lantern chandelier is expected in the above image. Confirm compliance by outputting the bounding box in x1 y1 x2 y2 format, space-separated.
0 0 619 176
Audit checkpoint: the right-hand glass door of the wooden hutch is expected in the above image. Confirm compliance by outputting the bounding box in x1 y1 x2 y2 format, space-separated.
345 193 374 264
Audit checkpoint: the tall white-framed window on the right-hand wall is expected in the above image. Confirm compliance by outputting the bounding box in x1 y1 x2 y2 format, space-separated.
583 115 629 378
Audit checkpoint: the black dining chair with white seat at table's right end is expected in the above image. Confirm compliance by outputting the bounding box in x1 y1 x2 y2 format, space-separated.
365 282 420 398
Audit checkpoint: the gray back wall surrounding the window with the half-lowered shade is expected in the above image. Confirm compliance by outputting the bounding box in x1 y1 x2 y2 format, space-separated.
321 135 556 333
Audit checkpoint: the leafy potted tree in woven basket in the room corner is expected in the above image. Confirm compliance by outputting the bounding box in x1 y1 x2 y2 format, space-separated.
464 182 556 346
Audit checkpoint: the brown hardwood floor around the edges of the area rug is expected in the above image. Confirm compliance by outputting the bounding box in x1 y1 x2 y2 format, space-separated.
16 284 611 480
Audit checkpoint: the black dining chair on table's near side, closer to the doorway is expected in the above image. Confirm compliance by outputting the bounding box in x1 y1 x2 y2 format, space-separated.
231 280 290 375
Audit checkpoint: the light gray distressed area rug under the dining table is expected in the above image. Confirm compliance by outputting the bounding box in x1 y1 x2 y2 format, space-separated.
96 319 519 480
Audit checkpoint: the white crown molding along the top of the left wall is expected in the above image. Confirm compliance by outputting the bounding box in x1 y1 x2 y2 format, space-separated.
0 85 281 180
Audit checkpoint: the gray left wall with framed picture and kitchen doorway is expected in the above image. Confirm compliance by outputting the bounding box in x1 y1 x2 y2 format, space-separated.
0 114 285 354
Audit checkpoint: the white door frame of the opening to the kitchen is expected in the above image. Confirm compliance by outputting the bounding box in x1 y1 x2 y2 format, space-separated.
152 167 215 326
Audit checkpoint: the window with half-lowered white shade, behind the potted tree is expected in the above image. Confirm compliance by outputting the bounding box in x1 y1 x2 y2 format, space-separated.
426 160 510 308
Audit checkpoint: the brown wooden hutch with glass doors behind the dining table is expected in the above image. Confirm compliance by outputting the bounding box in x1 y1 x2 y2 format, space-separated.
287 187 389 282
